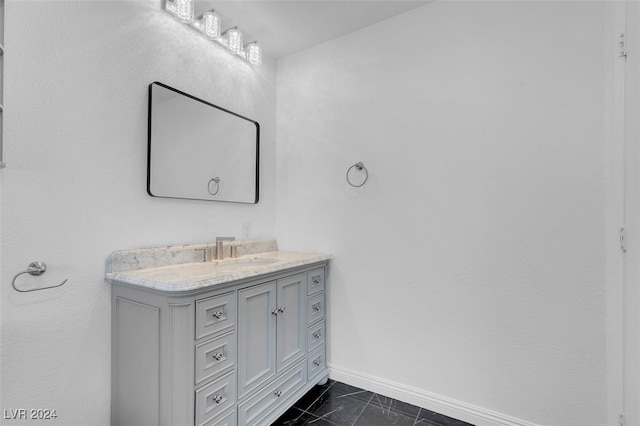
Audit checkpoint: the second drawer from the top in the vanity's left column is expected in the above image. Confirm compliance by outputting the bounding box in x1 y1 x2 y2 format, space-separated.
195 333 236 385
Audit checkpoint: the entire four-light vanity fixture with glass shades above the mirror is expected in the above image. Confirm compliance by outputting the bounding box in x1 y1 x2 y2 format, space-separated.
164 0 262 65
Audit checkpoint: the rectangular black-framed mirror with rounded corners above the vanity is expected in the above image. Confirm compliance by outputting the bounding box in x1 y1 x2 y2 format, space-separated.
147 81 260 204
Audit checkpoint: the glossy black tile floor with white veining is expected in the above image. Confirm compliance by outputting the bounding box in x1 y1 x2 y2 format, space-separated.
272 380 472 426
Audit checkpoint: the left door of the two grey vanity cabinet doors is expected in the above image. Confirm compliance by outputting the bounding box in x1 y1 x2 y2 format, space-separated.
237 281 278 398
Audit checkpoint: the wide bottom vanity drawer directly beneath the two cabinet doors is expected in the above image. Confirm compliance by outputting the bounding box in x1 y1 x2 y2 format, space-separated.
238 362 307 426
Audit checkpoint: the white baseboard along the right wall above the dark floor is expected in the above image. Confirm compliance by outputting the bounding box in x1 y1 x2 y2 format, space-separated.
328 364 539 426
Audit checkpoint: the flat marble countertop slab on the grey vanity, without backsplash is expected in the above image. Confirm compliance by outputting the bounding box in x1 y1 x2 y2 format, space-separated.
105 250 331 292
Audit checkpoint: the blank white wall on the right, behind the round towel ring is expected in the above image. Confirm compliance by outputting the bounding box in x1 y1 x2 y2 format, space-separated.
277 2 606 426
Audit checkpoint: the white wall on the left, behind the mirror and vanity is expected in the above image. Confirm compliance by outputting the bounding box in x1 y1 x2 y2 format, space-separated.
0 0 275 425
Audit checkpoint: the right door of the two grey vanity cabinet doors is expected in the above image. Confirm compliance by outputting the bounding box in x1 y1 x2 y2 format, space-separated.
276 274 307 371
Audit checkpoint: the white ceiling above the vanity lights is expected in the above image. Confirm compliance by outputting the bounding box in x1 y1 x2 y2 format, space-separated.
190 0 433 59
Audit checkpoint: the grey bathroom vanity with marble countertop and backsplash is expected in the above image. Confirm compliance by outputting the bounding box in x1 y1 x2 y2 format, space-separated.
106 240 330 426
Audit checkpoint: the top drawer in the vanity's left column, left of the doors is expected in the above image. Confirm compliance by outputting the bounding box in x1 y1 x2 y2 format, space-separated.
196 292 236 340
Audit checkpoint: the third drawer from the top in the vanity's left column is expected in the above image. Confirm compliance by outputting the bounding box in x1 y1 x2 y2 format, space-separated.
196 371 236 426
